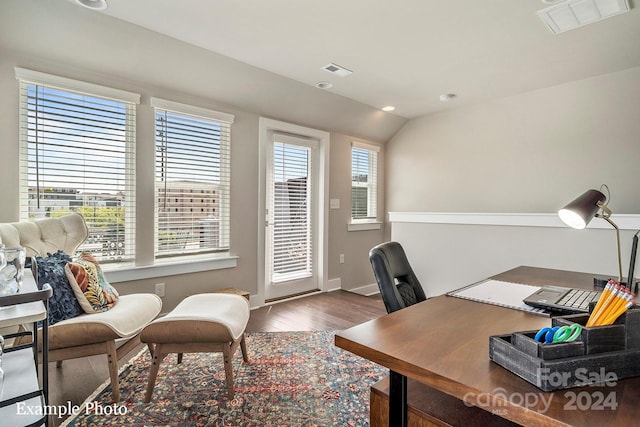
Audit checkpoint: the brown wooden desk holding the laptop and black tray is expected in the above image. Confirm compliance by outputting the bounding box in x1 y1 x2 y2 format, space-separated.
335 267 640 426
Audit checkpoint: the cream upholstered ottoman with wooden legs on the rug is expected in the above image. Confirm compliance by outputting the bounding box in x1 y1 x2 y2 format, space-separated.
140 294 249 402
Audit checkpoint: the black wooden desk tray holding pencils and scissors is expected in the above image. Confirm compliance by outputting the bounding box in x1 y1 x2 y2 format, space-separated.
489 309 640 391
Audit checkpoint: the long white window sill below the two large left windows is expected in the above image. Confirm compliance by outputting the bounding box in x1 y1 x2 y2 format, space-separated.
104 254 238 283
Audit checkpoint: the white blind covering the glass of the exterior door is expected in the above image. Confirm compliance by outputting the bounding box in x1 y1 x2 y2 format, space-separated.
269 135 313 283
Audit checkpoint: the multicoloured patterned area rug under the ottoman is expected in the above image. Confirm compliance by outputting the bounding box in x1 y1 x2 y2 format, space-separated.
63 332 388 427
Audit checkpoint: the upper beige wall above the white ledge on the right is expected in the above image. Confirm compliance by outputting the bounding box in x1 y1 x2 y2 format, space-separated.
387 68 640 214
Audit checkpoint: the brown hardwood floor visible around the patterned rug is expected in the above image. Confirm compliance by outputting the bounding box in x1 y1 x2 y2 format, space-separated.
47 291 386 426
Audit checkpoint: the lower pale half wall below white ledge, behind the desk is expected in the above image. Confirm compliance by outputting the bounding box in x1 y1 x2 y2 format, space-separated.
391 215 640 296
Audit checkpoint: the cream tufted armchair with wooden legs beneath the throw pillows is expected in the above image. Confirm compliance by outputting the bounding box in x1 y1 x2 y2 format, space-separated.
0 213 162 402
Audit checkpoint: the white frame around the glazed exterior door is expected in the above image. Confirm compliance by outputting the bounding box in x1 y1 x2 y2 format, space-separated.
256 117 330 306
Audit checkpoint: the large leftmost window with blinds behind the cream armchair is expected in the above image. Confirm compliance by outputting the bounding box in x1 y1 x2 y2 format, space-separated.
16 68 140 262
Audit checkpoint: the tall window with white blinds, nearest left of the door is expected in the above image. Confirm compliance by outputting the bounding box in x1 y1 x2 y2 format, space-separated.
151 98 234 257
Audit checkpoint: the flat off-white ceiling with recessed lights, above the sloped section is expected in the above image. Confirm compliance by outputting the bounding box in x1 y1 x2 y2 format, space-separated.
100 0 640 118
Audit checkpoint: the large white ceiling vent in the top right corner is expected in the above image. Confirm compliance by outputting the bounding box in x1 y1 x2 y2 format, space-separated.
538 0 629 34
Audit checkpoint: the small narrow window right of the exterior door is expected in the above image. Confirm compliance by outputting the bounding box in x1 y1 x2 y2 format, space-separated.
351 141 380 222
